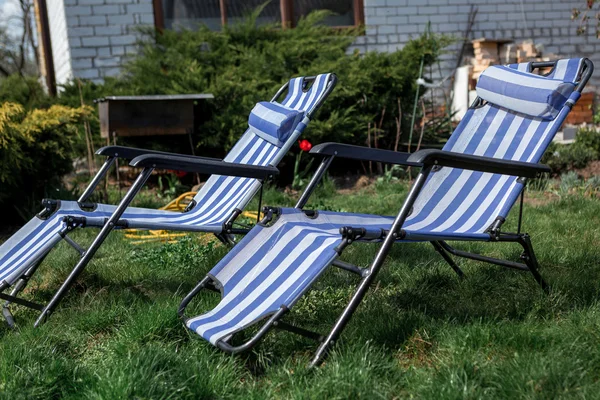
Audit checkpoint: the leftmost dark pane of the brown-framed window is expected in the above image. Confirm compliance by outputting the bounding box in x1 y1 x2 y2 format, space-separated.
162 0 221 30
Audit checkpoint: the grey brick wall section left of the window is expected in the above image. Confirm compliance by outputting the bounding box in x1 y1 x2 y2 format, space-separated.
54 0 154 84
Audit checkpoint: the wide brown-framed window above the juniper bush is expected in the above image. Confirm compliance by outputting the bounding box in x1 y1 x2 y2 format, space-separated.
153 0 364 30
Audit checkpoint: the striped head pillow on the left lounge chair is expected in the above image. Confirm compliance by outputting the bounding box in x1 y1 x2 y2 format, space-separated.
248 101 304 147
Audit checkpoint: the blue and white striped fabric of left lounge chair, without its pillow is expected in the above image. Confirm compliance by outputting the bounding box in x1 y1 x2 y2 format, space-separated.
0 74 331 284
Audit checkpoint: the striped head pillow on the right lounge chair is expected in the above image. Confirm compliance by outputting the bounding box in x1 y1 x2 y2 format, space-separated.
477 65 575 120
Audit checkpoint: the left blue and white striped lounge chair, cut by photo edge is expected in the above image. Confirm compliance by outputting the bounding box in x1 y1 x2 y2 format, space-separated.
0 74 337 325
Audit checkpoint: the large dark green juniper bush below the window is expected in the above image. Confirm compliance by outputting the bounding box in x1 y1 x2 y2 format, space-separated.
61 8 450 158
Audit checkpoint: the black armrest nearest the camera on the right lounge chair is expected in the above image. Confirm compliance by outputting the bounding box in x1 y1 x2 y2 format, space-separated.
408 149 551 178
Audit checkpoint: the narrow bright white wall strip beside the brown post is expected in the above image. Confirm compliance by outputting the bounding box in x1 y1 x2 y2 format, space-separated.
46 0 73 84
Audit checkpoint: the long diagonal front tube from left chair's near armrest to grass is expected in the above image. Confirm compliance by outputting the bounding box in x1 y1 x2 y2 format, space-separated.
34 168 154 327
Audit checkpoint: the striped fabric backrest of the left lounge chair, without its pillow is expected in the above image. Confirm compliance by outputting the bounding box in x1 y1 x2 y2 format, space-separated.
186 74 332 225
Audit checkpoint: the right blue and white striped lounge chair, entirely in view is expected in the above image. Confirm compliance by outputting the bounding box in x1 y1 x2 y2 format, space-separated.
179 59 593 365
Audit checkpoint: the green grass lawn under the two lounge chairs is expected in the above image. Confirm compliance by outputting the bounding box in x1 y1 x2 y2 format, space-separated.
0 184 600 399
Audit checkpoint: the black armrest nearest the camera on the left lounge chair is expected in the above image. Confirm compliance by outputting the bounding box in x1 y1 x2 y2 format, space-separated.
129 154 279 179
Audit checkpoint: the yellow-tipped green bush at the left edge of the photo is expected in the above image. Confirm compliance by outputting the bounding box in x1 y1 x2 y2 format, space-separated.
0 102 91 223
